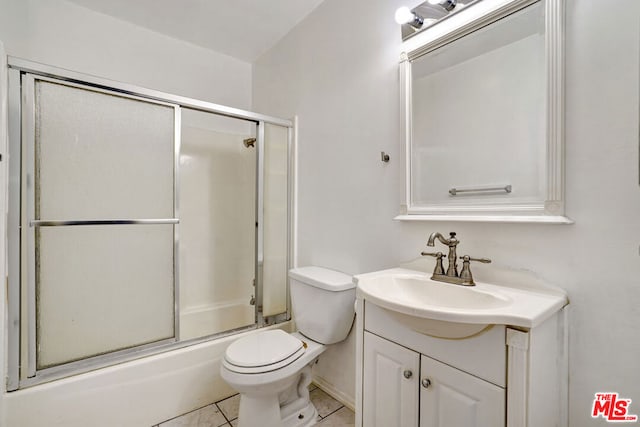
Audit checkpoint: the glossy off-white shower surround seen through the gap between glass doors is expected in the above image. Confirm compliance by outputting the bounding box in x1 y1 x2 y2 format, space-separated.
178 109 257 339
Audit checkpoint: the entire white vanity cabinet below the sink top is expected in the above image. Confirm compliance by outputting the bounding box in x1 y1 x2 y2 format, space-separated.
356 298 566 427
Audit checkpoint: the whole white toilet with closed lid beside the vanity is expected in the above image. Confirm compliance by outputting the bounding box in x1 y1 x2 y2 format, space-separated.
220 266 355 427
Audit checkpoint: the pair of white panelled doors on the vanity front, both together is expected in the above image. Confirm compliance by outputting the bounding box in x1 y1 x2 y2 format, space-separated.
362 332 505 427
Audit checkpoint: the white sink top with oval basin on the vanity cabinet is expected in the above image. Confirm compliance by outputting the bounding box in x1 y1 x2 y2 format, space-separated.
354 268 567 339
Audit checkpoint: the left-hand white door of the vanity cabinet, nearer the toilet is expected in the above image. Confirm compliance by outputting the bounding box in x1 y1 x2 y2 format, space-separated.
362 332 420 427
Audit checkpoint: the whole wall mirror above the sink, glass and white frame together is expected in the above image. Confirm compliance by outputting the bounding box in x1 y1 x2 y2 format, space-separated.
397 0 571 223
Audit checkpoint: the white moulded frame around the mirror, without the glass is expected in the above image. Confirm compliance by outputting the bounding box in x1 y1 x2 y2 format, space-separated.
395 0 573 224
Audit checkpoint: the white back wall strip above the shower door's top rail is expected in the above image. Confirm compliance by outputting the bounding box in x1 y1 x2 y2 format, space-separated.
0 0 251 109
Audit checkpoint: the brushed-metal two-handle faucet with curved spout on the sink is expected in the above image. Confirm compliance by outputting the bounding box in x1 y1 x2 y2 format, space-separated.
421 232 491 286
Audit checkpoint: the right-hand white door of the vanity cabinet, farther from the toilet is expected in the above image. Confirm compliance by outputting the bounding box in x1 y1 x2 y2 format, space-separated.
420 356 505 427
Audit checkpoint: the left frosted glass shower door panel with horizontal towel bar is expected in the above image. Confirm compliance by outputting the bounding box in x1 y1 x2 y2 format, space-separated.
23 76 179 373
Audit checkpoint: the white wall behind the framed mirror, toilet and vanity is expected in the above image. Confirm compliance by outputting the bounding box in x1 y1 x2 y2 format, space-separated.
253 0 640 427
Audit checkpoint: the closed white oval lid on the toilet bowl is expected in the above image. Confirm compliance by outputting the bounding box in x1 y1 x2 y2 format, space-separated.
224 329 304 372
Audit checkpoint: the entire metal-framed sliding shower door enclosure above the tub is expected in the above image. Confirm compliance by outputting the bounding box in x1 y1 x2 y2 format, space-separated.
8 58 293 390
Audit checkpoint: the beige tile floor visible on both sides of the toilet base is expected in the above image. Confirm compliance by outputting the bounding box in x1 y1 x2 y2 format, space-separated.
154 384 355 427
